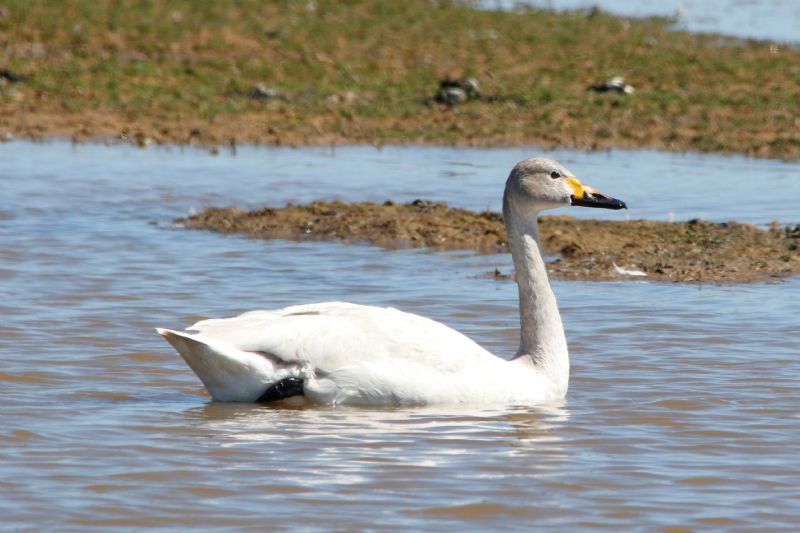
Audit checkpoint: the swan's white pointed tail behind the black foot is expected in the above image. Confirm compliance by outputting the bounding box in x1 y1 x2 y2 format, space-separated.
156 328 280 402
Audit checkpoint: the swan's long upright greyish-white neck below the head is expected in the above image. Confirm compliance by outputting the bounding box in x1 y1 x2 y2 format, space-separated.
503 193 569 393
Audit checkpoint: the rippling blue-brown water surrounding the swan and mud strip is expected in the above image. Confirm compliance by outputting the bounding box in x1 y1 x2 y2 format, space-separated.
0 143 800 531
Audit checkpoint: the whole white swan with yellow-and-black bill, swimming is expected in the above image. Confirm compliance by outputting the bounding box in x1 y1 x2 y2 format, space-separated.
157 158 625 405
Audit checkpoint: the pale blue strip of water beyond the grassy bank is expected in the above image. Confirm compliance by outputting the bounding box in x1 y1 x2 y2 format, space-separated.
482 0 800 43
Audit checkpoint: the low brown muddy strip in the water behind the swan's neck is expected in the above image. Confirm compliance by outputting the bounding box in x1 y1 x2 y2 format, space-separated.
176 200 800 283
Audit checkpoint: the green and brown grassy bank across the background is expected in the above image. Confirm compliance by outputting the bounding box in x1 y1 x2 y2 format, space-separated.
0 0 800 158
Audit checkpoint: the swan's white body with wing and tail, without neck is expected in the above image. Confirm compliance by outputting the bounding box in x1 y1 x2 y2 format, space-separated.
165 302 564 405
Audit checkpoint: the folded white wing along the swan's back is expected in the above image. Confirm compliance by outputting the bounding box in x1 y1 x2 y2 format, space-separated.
189 302 496 374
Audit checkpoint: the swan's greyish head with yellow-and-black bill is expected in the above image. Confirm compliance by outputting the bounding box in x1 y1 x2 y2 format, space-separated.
503 157 627 216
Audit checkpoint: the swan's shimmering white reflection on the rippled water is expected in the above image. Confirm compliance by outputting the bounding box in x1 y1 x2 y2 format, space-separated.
185 402 569 488
